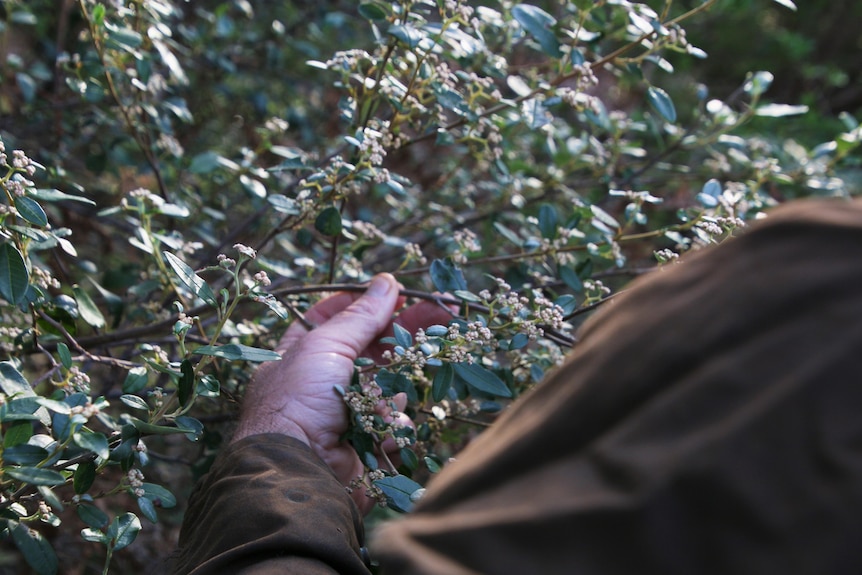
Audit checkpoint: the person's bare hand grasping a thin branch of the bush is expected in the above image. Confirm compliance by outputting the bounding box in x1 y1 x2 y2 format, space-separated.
234 274 449 511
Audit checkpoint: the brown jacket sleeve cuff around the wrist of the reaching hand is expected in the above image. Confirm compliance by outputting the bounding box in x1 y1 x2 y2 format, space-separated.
173 434 369 575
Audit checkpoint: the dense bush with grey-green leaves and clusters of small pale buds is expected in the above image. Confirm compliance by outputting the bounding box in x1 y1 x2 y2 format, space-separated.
0 0 862 574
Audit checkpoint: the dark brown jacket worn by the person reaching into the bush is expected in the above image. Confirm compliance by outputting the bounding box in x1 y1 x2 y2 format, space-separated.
172 197 862 575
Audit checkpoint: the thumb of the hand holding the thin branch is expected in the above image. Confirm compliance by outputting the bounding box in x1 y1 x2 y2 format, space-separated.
307 274 398 359
